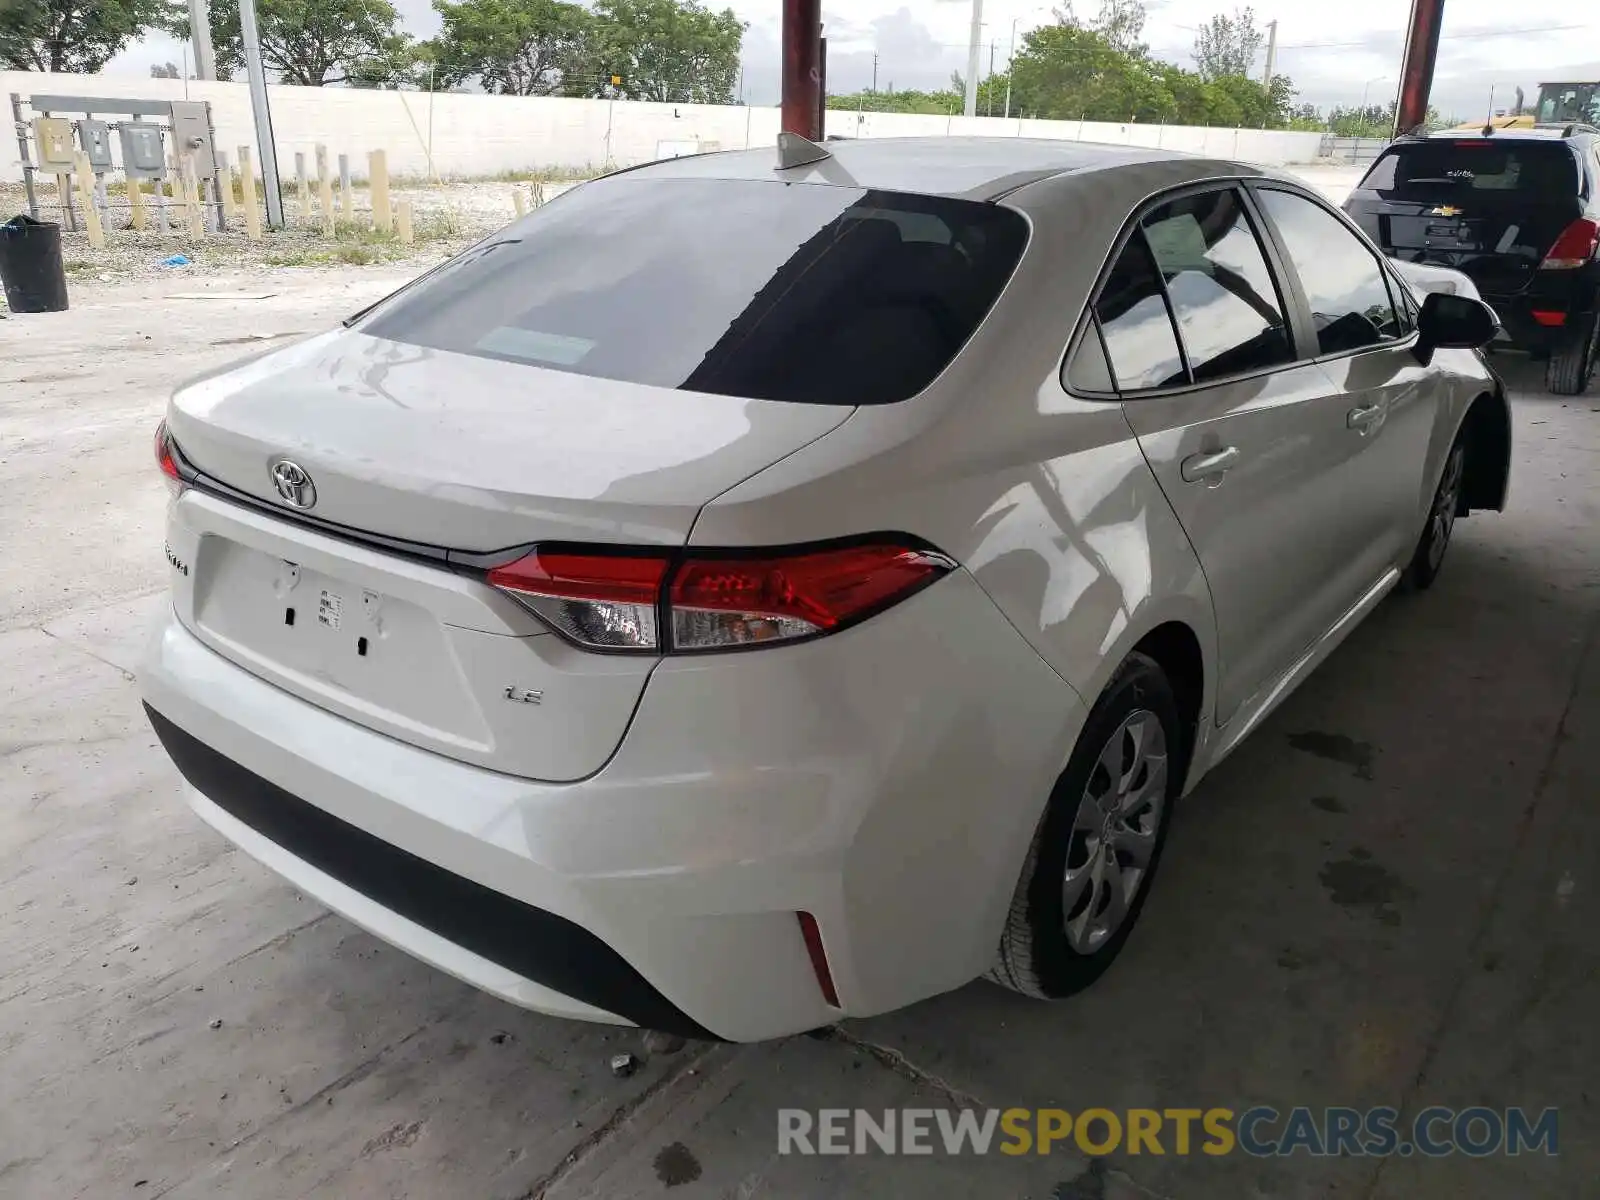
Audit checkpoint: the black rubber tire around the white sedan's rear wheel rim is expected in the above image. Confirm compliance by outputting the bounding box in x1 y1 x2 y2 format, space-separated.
989 653 1189 1000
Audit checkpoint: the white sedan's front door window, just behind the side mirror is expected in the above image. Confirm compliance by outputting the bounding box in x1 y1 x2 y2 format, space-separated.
1258 189 1406 354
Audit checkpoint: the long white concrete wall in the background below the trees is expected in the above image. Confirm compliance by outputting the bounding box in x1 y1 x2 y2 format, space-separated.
0 72 1322 181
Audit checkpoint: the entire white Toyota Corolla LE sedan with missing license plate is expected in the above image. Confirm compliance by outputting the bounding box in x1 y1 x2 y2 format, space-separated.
139 139 1510 1042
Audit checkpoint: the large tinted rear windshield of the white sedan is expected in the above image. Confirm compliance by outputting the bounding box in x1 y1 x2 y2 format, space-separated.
362 174 1027 405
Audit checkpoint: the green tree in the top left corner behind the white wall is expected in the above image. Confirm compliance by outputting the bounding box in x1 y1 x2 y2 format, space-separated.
0 0 187 75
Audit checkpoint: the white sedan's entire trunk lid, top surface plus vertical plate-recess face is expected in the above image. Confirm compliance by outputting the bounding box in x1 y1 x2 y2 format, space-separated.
166 331 853 781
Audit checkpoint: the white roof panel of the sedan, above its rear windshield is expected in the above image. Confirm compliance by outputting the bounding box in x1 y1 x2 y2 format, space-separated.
629 138 1267 200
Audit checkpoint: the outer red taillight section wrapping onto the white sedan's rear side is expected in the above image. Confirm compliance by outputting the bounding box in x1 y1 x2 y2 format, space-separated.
669 544 950 650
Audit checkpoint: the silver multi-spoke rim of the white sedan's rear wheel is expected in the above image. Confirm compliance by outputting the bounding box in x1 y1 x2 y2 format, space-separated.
1061 709 1166 954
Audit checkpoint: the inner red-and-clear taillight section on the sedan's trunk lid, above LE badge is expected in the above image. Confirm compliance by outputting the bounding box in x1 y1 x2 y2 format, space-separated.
488 550 667 651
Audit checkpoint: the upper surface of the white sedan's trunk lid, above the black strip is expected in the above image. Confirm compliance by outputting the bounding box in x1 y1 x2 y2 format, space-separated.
168 330 851 552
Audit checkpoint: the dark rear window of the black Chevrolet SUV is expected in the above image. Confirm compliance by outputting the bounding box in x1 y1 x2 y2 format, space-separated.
1362 138 1578 198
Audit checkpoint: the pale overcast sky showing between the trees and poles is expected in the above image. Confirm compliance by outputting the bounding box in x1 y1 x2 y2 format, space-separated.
110 0 1600 118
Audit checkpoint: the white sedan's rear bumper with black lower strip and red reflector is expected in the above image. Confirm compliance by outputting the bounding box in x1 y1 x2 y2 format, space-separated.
139 573 1083 1042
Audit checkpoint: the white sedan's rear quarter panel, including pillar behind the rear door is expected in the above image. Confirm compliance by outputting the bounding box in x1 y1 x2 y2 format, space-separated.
690 160 1237 790
